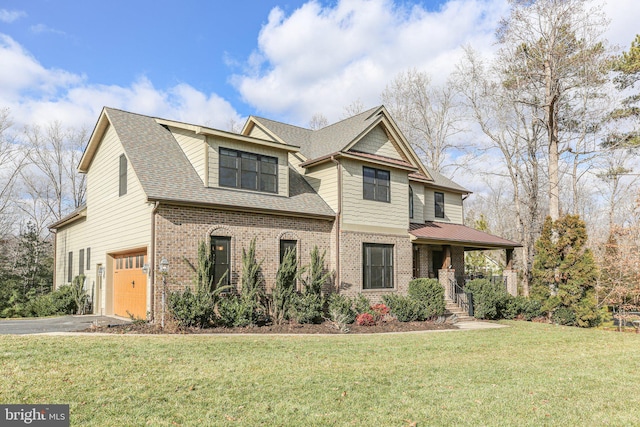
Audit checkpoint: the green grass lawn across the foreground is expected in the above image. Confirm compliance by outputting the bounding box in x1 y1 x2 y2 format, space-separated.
0 322 640 426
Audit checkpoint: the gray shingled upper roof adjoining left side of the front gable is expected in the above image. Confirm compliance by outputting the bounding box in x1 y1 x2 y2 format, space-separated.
254 107 380 160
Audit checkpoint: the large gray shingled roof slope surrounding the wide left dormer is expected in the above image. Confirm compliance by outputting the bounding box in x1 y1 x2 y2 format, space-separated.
105 108 335 217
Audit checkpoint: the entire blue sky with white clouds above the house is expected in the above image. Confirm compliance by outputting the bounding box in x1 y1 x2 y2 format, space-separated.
0 0 640 129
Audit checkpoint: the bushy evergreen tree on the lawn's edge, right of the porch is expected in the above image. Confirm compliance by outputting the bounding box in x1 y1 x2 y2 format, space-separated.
531 215 600 327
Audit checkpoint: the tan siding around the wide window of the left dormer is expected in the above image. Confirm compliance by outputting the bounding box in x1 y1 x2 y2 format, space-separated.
207 136 289 197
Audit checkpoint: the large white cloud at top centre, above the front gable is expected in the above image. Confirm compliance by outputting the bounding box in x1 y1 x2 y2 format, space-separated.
233 0 506 123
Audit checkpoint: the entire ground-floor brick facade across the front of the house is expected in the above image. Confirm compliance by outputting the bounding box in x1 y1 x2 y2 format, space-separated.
154 205 472 316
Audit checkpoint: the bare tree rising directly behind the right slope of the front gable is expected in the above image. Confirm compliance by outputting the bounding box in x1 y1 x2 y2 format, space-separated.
382 69 463 172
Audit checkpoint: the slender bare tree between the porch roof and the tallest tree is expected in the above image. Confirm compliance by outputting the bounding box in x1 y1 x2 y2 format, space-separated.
454 48 544 295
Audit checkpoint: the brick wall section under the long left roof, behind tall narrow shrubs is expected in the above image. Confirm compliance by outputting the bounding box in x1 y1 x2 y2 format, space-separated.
154 205 335 315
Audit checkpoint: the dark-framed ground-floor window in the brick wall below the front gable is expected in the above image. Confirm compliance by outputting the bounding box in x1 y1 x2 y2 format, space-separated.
362 243 393 289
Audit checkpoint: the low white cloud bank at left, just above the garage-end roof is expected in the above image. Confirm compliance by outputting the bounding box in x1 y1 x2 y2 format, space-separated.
0 34 242 129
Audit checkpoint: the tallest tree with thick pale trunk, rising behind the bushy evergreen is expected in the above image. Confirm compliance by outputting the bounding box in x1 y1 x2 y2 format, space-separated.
497 0 608 220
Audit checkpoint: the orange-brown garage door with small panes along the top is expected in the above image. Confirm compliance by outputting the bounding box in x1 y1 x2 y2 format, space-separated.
113 253 147 319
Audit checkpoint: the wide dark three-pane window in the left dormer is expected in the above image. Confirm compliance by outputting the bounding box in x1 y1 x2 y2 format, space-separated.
219 148 278 193
